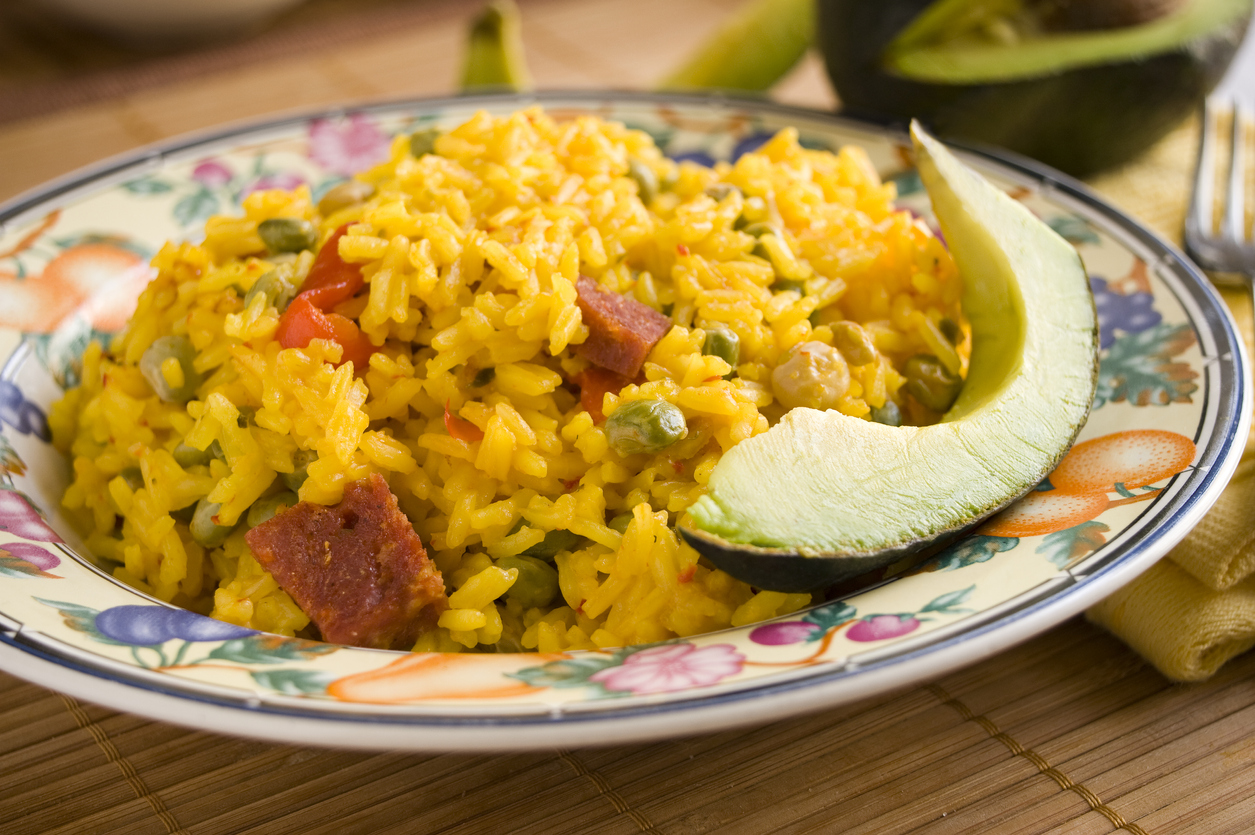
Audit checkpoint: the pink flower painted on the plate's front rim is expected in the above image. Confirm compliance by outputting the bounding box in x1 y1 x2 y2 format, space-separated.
589 644 745 696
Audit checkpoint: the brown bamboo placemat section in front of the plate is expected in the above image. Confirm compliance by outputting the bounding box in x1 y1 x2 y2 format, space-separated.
7 620 1255 835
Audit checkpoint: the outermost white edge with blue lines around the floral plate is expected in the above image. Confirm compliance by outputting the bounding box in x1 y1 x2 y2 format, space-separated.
0 88 1251 751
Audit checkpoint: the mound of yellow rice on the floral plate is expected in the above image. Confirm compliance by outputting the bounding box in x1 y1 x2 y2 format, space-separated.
50 109 966 652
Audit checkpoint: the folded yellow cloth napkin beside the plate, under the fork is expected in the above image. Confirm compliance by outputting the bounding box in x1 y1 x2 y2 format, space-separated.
1087 289 1255 682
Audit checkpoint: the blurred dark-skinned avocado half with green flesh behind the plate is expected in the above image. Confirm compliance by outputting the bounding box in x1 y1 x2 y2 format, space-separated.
816 0 1252 177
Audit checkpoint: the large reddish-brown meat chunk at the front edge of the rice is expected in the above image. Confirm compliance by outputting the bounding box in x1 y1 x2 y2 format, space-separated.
245 475 449 649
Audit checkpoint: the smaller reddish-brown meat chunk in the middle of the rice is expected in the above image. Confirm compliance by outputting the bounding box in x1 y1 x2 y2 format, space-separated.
575 275 671 379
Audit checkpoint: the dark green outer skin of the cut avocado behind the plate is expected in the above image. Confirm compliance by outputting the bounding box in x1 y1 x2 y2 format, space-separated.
816 0 1249 177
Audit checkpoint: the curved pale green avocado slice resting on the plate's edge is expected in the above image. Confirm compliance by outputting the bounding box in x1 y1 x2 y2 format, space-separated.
681 124 1098 591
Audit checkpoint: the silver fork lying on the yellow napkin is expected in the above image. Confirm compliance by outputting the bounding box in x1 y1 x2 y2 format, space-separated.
1185 98 1255 288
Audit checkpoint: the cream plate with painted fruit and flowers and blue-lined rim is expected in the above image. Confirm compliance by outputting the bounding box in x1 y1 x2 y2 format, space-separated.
0 93 1250 751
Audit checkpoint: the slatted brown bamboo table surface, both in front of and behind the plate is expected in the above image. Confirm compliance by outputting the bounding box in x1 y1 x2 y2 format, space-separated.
0 0 1255 835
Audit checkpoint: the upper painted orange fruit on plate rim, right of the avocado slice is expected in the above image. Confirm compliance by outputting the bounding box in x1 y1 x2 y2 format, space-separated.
1050 429 1195 492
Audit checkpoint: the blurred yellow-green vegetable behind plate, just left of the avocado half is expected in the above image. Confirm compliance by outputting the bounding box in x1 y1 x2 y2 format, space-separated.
659 0 814 90
